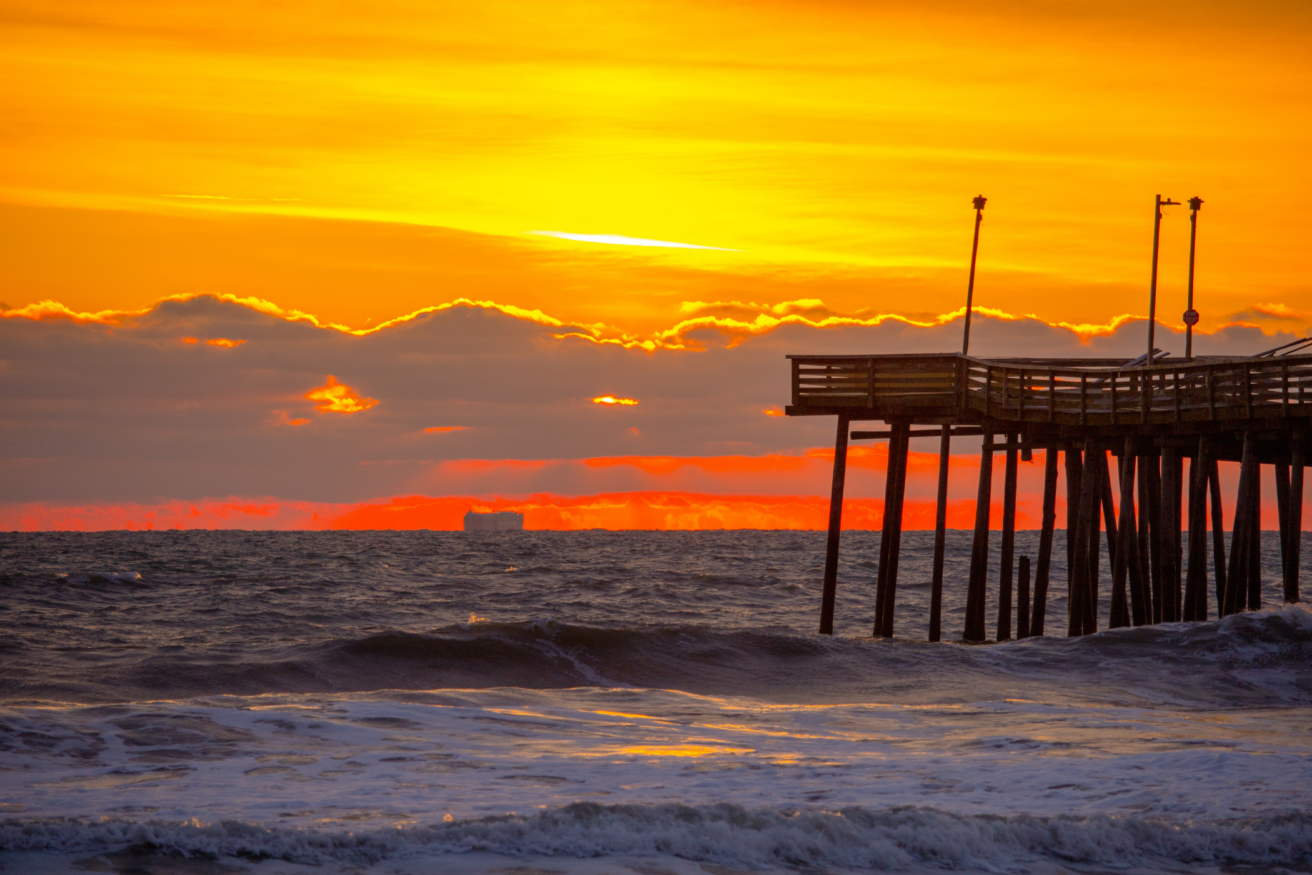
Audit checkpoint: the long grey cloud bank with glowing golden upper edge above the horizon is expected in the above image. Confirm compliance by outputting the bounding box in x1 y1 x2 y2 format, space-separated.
0 296 1294 505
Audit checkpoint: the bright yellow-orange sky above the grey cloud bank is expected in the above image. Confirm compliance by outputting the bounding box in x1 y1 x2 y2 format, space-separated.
0 0 1312 335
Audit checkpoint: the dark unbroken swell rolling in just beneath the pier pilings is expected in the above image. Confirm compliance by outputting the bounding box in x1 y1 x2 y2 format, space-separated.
312 605 1312 706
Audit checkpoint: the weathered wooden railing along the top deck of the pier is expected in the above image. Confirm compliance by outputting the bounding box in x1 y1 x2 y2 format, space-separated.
789 354 1312 425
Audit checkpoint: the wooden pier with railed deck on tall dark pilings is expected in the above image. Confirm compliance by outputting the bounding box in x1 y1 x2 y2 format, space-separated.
786 350 1312 641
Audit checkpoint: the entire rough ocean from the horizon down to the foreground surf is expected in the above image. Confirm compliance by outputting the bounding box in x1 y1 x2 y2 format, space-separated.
0 531 1312 875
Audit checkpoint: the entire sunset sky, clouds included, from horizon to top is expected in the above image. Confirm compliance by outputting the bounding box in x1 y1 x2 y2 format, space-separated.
0 0 1312 529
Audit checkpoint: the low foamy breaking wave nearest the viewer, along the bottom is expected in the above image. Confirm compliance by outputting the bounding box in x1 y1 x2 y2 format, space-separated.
0 803 1312 870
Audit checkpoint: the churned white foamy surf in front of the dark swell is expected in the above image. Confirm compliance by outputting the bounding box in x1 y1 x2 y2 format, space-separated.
0 689 1312 870
